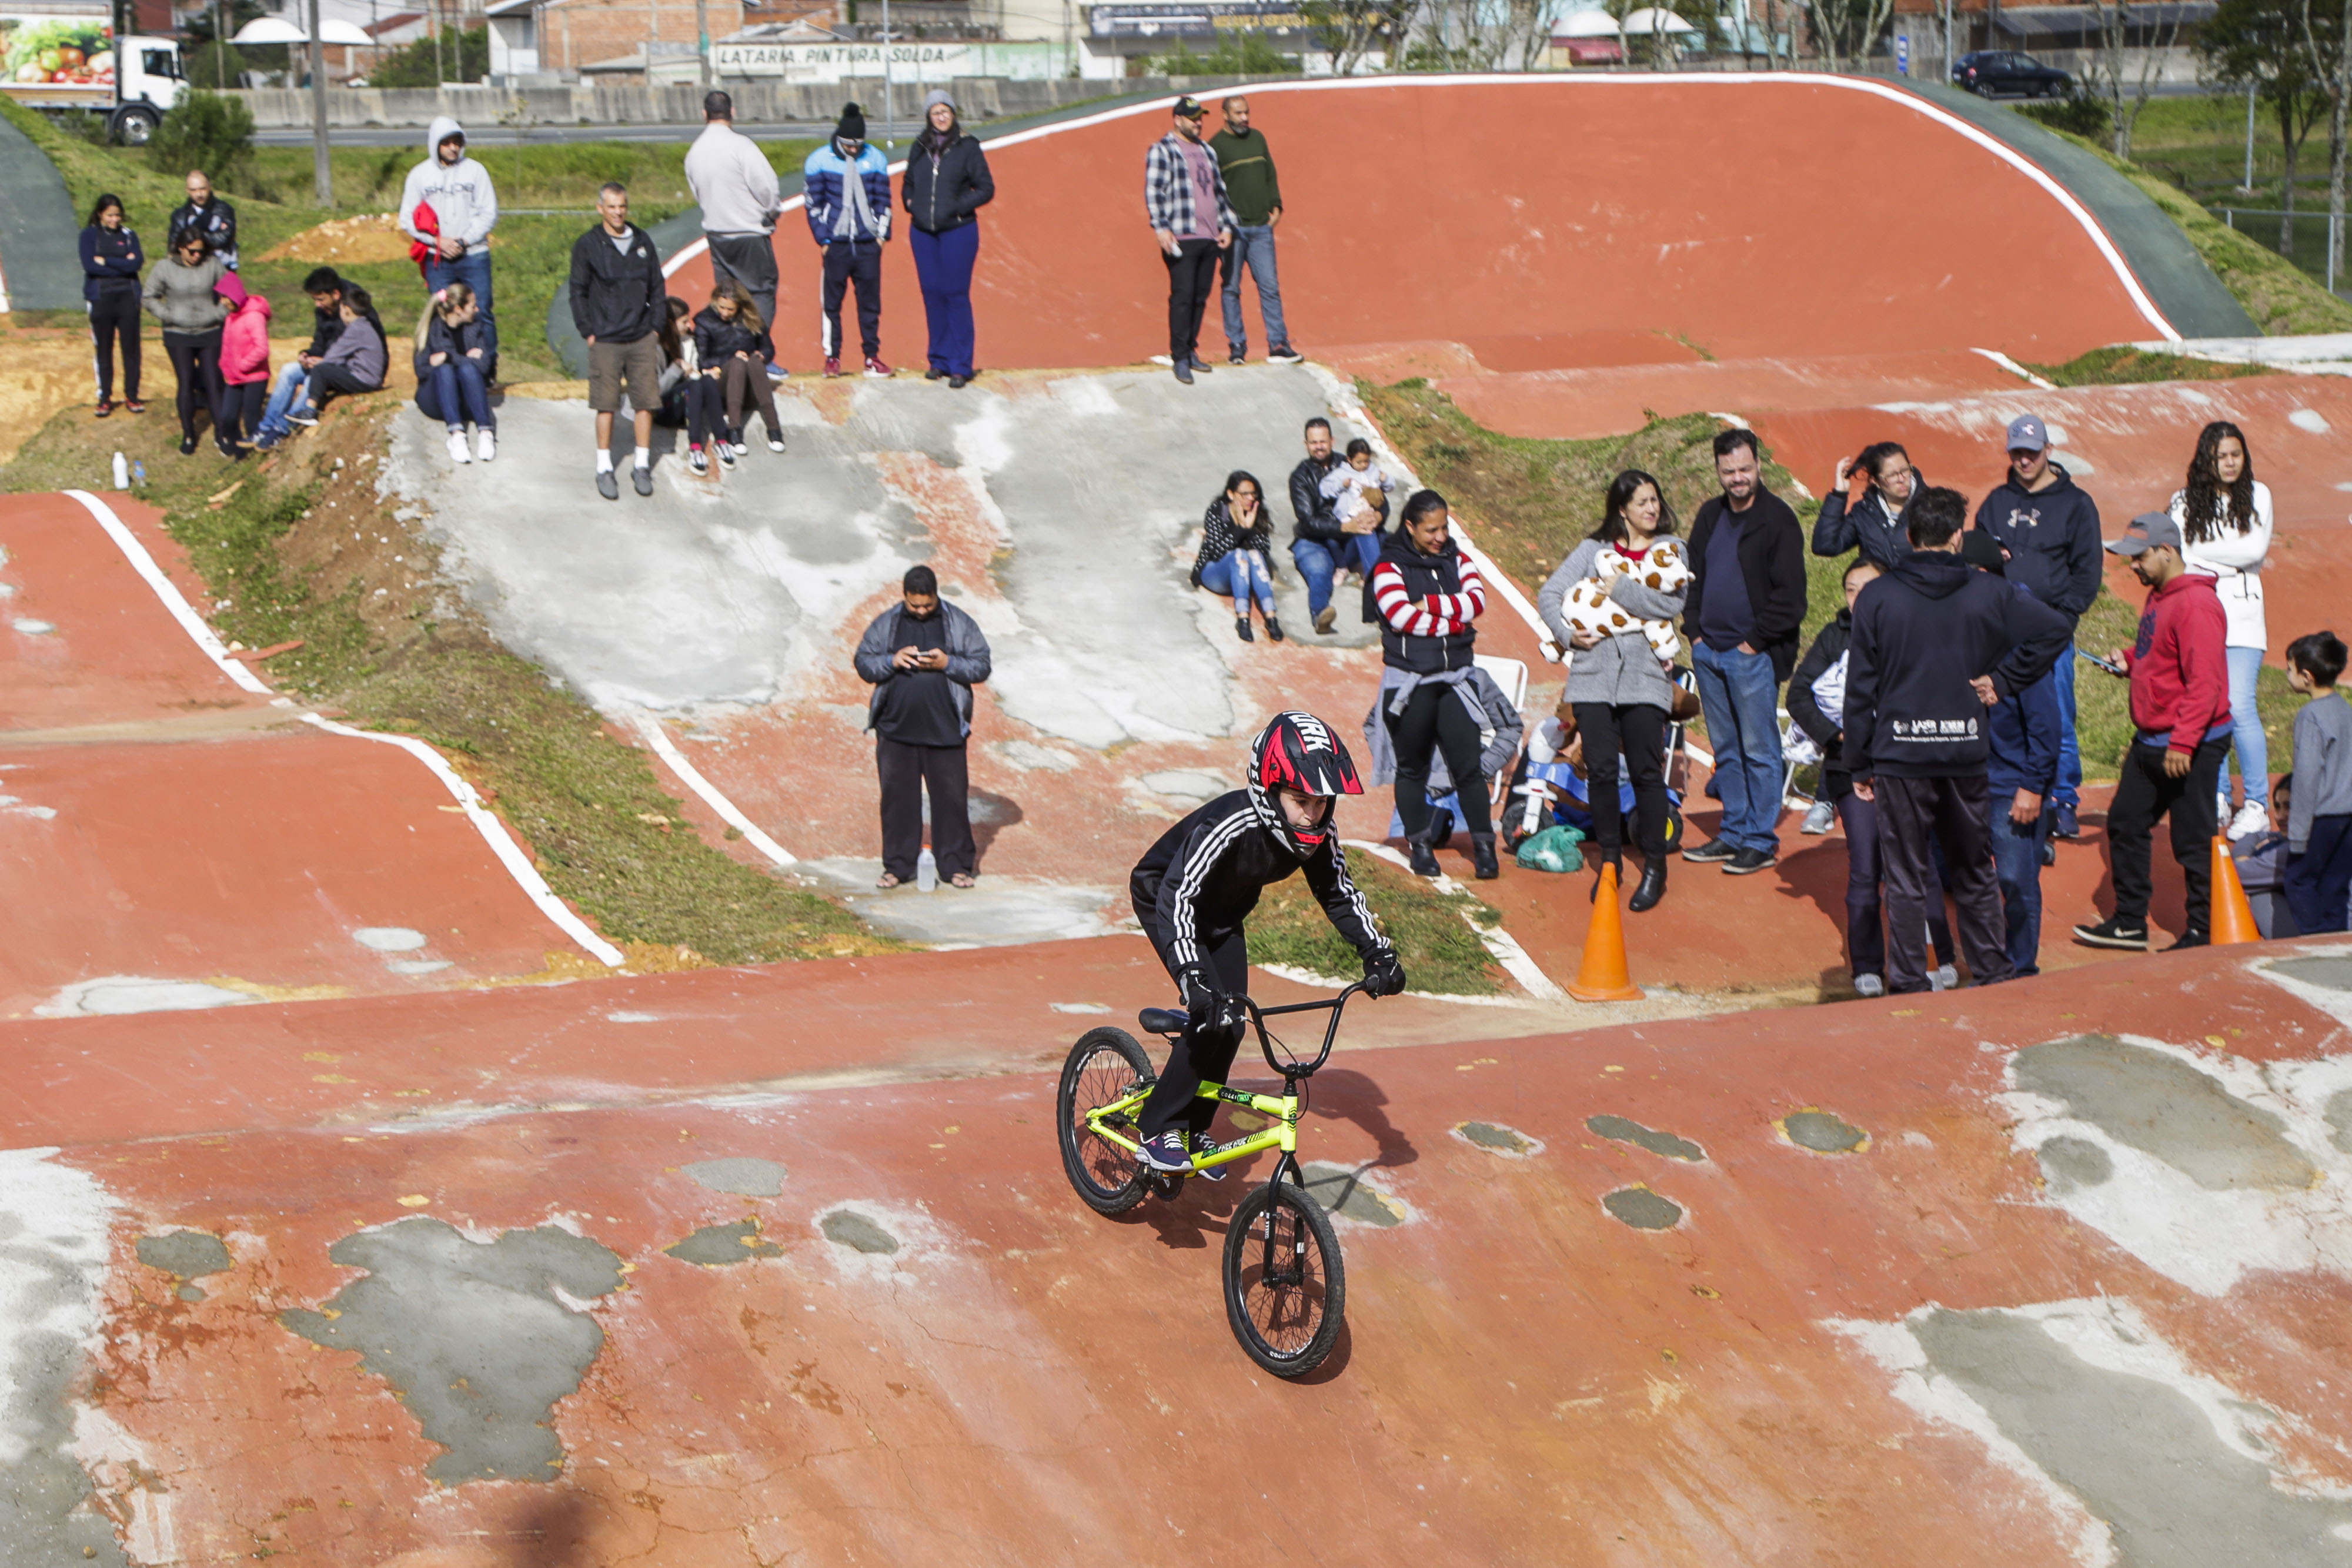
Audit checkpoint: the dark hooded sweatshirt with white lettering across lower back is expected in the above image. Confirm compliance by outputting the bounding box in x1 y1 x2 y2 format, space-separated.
1844 550 2074 783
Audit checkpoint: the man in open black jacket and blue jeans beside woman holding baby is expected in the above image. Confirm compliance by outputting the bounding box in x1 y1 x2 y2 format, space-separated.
1682 430 1804 877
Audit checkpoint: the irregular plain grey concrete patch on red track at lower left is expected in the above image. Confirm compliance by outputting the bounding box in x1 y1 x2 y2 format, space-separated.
278 1218 621 1486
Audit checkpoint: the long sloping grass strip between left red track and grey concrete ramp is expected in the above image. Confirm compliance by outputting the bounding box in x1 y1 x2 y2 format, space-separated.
0 395 896 966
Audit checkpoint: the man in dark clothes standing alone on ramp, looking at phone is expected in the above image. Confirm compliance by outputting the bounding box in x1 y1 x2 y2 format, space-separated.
856 567 988 888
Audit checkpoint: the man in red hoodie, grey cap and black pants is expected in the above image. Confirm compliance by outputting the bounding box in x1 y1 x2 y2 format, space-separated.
2074 513 2230 952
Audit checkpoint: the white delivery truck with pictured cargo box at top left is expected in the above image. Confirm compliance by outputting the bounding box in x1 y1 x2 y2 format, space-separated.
0 0 188 146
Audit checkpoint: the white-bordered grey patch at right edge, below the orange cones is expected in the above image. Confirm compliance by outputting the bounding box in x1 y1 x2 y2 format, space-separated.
2002 1034 2352 1295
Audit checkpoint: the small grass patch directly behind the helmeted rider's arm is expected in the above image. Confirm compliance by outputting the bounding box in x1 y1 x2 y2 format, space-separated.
1249 851 1505 997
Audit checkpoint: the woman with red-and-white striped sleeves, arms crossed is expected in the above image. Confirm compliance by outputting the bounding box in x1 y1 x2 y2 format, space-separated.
1371 489 1503 881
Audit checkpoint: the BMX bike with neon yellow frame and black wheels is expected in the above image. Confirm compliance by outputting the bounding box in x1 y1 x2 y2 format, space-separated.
1056 982 1364 1378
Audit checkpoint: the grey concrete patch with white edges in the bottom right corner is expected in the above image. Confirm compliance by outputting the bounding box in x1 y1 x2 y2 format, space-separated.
1830 1298 2352 1568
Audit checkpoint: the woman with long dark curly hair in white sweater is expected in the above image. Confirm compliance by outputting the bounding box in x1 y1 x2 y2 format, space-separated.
2171 419 2300 839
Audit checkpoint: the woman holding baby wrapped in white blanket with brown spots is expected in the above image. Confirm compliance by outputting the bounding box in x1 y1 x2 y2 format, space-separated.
1536 468 1691 912
